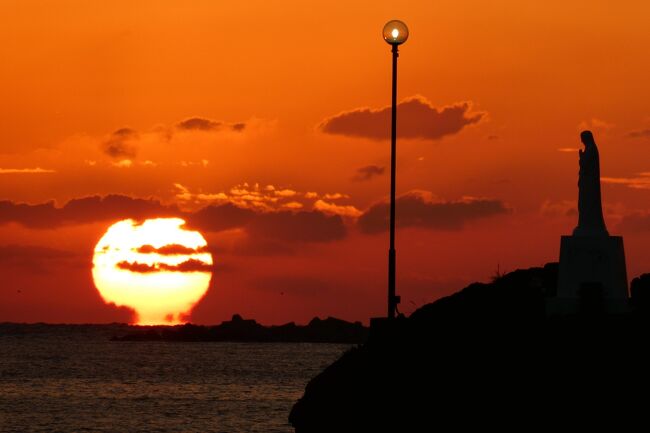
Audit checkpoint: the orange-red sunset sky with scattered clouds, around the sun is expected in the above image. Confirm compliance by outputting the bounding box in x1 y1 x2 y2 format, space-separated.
0 0 650 324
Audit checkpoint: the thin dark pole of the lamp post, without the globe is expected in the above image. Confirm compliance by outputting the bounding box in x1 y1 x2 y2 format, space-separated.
388 44 400 319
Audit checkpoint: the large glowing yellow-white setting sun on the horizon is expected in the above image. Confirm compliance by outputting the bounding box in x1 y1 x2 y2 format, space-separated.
93 218 213 325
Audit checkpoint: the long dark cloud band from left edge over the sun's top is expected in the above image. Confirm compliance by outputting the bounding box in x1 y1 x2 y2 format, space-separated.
0 189 347 243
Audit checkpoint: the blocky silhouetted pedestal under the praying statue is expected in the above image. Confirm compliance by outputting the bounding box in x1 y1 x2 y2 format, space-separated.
553 236 628 312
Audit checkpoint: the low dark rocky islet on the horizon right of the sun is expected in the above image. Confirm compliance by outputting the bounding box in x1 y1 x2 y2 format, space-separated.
112 314 368 344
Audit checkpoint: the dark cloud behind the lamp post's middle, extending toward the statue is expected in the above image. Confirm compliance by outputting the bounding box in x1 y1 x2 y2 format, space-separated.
357 191 509 233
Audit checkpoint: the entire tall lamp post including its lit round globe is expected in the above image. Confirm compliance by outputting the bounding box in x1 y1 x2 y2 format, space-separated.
383 20 409 319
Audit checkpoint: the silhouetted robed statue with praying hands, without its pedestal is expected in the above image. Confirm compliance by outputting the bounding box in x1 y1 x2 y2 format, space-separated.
573 131 608 236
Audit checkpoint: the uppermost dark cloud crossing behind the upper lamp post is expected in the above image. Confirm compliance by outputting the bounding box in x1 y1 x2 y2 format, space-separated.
319 96 486 140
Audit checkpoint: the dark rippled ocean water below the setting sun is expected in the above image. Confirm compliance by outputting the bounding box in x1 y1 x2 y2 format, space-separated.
0 324 349 433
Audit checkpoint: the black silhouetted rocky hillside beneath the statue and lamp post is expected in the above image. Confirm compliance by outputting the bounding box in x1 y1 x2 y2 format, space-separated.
289 263 650 433
